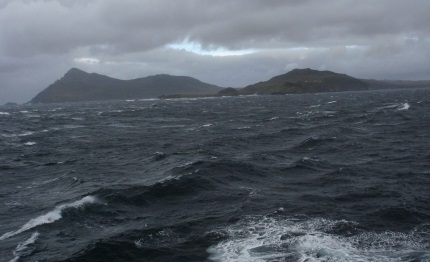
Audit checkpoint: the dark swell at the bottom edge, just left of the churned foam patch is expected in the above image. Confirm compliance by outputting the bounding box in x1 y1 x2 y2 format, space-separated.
63 225 226 262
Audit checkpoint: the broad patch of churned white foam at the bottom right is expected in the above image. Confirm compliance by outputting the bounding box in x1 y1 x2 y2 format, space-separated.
208 216 430 262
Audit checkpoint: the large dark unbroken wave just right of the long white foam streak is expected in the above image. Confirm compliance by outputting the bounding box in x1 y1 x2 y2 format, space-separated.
92 160 264 206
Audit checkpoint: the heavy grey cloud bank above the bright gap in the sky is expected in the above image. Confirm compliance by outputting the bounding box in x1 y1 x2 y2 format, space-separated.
0 0 430 55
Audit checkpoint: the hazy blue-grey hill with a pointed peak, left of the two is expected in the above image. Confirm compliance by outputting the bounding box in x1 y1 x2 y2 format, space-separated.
30 68 221 103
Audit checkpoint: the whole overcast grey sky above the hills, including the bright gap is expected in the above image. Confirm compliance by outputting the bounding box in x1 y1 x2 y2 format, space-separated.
0 0 430 104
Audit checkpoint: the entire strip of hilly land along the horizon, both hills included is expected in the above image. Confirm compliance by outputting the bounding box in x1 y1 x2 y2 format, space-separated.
30 68 430 103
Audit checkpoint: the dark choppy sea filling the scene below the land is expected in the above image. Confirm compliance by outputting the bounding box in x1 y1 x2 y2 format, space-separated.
0 89 430 261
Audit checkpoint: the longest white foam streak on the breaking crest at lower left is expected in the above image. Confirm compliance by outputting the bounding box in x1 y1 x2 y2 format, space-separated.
0 196 97 241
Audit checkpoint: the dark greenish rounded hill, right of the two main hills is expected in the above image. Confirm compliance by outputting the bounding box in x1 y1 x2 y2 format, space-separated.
240 68 370 95
